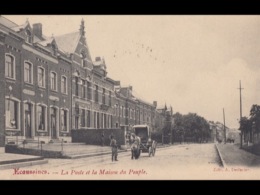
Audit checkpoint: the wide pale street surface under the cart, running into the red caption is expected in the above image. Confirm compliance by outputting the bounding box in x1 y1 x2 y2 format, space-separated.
0 143 228 180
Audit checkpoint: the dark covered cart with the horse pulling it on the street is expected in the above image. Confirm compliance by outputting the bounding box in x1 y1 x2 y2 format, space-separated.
131 125 157 159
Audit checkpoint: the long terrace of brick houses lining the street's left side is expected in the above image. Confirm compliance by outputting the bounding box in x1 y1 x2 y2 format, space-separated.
0 16 168 146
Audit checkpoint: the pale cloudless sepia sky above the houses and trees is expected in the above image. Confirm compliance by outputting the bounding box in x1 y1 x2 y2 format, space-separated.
5 15 260 128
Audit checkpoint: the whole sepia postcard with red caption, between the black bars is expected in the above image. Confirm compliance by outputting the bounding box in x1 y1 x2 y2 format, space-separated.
0 15 260 180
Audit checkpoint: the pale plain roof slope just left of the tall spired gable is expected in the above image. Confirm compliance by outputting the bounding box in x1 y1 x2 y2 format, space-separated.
55 31 80 53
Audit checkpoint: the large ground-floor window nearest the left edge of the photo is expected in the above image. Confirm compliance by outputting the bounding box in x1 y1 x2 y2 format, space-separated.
5 99 19 129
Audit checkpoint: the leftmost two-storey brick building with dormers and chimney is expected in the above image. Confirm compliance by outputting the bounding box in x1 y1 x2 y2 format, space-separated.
0 17 71 145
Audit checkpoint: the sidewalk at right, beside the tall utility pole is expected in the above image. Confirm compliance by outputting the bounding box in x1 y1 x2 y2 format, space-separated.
216 143 260 167
